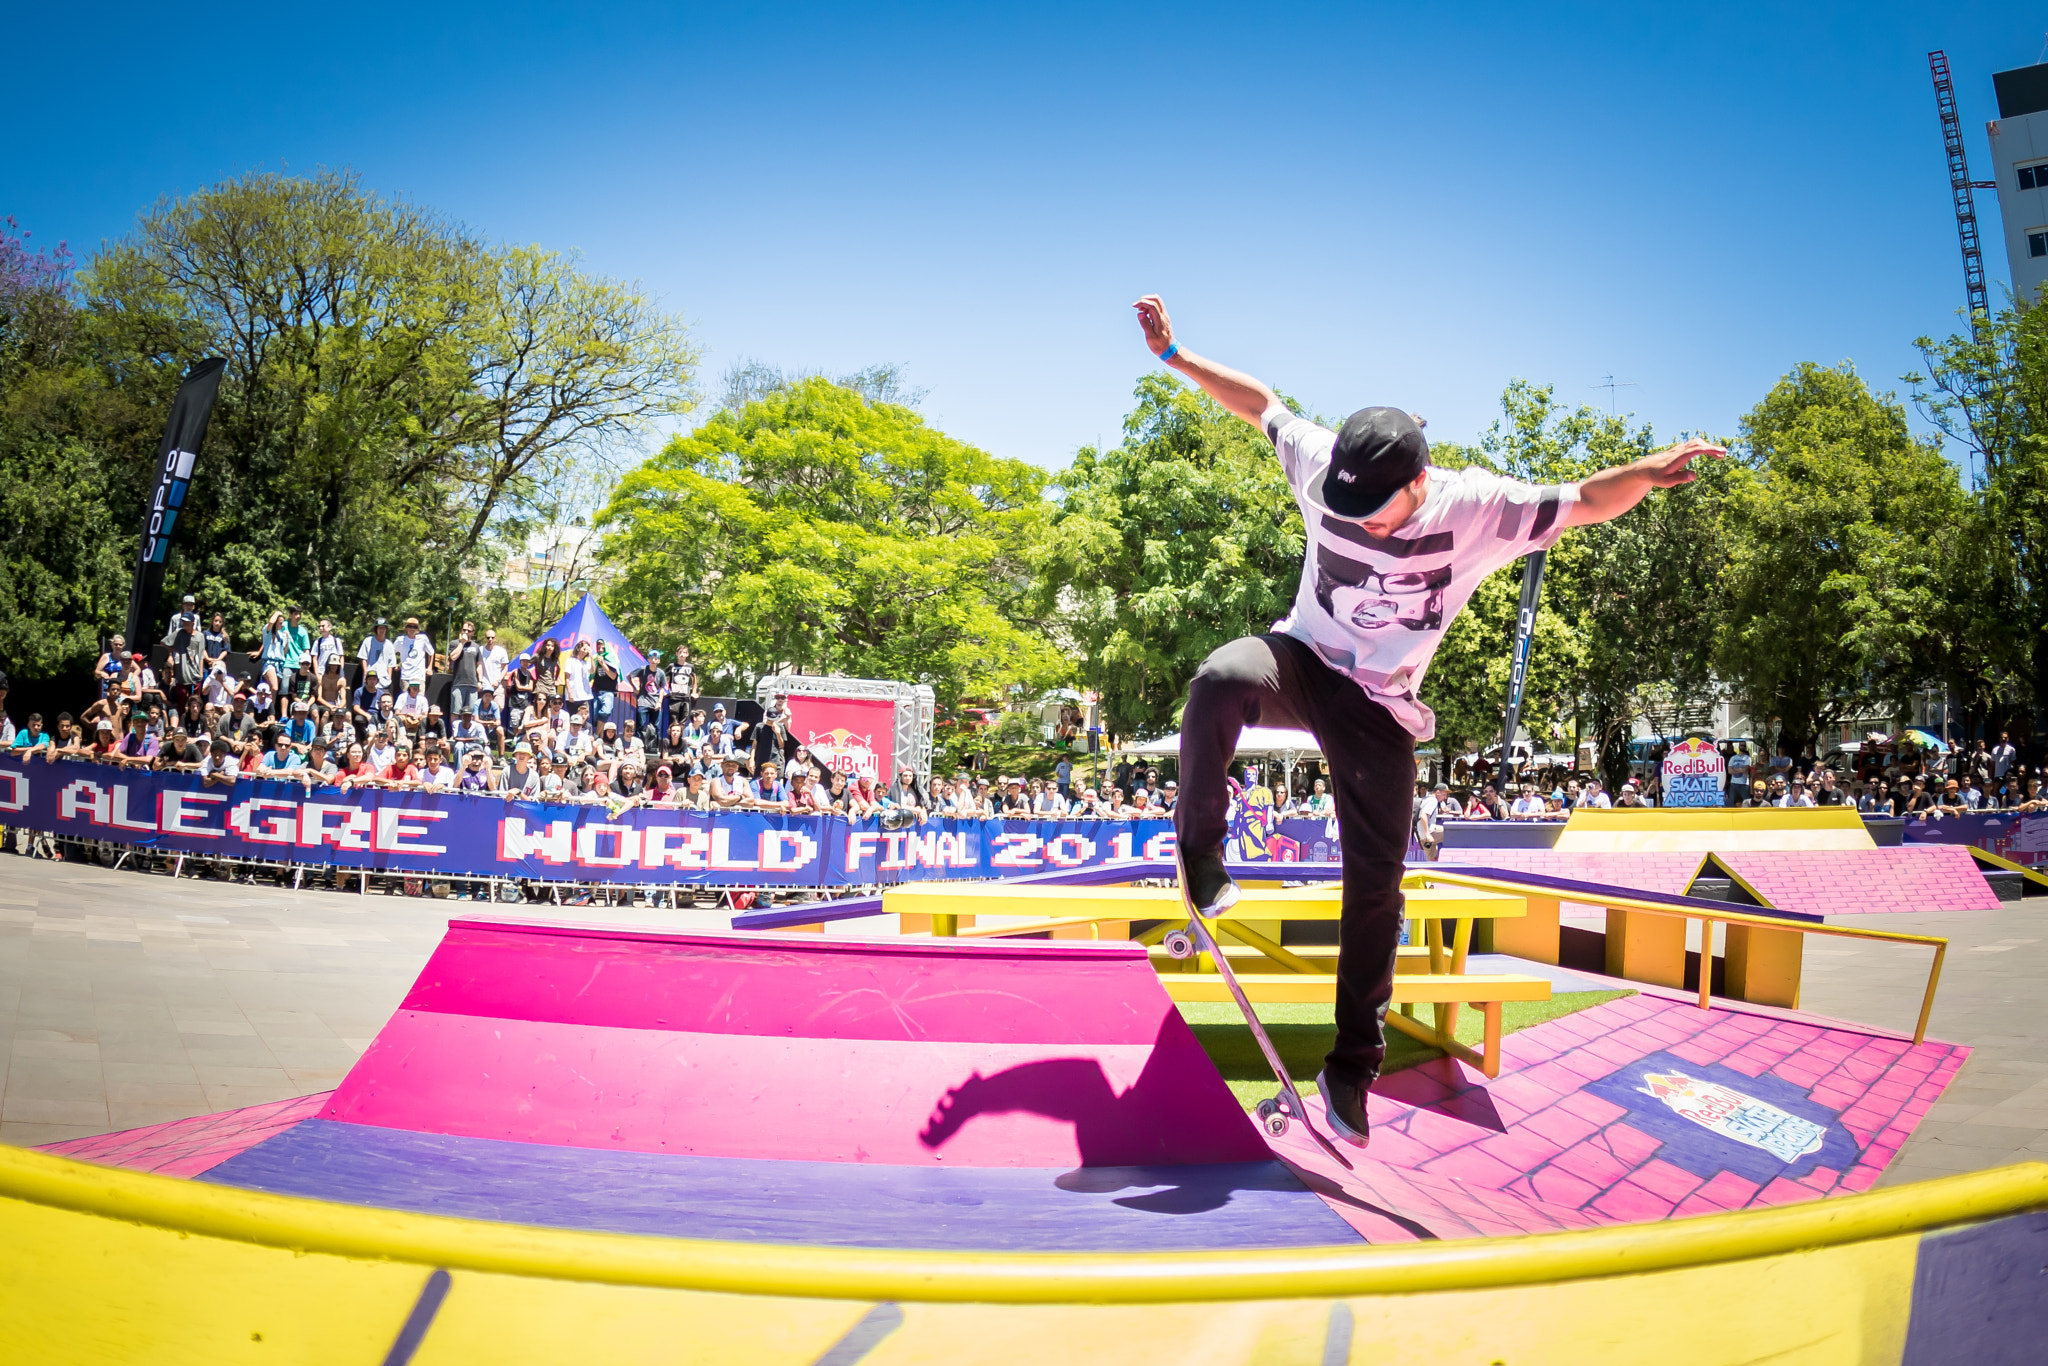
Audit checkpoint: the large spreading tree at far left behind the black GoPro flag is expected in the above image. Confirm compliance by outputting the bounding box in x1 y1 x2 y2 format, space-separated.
0 172 696 668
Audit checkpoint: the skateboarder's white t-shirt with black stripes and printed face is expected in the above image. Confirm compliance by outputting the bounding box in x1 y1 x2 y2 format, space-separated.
1262 403 1579 739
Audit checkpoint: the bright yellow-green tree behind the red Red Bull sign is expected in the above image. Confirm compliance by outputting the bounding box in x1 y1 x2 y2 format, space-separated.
596 377 1067 707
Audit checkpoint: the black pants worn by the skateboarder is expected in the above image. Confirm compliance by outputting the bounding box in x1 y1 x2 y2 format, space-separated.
1174 635 1415 1083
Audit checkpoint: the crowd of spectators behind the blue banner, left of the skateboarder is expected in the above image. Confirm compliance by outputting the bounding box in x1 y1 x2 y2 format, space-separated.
0 596 1176 819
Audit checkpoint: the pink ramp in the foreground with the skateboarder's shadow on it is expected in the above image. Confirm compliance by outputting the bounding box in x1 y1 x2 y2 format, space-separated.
322 920 1270 1167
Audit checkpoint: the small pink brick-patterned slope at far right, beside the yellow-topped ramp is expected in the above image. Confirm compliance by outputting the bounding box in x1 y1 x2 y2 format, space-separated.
1714 844 1999 915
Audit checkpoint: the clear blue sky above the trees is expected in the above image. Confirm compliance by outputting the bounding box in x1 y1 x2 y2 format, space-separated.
0 2 2048 467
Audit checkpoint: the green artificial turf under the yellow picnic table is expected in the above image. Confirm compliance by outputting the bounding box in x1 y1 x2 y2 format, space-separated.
1180 991 1634 1110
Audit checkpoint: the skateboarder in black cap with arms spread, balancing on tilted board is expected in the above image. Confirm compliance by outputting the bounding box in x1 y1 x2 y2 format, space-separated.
1135 295 1724 1147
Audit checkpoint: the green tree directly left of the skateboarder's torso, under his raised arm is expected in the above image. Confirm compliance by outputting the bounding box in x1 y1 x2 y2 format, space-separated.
1034 375 1303 737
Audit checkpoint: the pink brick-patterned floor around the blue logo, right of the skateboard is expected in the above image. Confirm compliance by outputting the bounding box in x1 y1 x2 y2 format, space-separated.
1274 993 1968 1241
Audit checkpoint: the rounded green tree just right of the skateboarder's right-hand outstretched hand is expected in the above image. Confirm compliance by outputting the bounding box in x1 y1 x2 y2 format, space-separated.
1718 362 1974 754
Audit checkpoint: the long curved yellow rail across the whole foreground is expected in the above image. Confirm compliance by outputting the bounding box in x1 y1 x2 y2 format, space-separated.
0 1149 2048 1305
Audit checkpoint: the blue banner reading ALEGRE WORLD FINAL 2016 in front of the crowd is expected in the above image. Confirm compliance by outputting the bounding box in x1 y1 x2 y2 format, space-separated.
0 758 1212 889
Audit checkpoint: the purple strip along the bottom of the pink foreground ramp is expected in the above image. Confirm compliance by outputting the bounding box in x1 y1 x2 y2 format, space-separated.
205 1120 1358 1251
